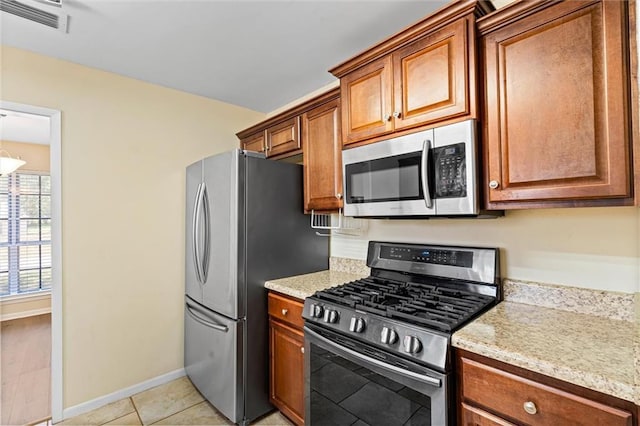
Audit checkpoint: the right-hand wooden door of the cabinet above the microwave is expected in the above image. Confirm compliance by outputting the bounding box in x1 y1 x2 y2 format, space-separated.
393 18 469 130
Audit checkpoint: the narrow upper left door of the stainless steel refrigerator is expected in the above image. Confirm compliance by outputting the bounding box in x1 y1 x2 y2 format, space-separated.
185 161 204 303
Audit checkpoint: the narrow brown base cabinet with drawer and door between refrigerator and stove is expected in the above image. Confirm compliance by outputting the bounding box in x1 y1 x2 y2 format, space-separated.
268 292 304 425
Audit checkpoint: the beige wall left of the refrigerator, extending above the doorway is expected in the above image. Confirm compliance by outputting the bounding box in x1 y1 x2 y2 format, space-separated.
0 46 264 408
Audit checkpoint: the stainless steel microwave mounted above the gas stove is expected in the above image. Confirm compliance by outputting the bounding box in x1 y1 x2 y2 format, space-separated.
342 120 501 217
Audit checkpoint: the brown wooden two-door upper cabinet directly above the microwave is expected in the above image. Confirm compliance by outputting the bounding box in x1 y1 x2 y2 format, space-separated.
331 1 490 145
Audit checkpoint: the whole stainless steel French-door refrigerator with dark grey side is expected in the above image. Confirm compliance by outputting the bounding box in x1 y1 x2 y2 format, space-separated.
184 150 329 424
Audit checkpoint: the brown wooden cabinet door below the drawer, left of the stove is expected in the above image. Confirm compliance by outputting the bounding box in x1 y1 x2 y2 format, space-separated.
269 319 304 425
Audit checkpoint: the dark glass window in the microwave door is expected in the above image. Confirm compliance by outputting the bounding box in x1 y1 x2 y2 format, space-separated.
345 152 424 204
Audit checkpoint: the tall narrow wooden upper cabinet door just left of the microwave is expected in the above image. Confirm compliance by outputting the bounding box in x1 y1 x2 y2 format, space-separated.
302 99 342 211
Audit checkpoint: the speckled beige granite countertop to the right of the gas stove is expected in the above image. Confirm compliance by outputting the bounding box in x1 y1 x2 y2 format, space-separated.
452 301 640 404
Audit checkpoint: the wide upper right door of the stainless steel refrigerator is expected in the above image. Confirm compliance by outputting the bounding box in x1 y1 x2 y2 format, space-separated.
202 150 244 319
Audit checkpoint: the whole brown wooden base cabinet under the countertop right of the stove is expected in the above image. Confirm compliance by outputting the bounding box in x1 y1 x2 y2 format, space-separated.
457 351 637 426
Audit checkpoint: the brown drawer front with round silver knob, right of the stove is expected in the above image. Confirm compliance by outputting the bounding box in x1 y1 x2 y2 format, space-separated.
461 358 632 426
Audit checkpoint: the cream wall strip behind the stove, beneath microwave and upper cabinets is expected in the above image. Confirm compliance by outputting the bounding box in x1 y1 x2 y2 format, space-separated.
331 207 640 293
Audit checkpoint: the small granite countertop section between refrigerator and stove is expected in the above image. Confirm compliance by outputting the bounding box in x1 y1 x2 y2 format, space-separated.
264 270 366 300
